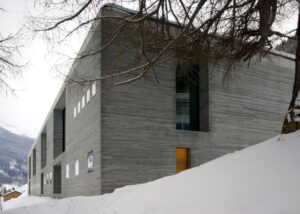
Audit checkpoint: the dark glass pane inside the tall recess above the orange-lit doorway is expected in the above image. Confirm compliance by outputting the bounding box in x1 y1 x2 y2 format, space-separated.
176 65 199 131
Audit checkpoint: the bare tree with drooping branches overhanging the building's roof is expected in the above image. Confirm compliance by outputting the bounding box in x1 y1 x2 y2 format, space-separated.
30 0 300 133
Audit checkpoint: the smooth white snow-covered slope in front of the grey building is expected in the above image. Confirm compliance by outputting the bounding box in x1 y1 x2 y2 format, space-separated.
3 131 300 214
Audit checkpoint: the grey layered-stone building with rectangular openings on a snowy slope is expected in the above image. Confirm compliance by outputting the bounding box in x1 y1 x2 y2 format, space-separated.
28 4 294 198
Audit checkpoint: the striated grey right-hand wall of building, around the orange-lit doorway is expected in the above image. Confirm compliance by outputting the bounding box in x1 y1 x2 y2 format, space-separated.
101 7 294 193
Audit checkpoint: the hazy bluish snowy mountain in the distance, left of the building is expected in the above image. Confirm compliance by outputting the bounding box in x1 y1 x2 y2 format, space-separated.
0 127 34 185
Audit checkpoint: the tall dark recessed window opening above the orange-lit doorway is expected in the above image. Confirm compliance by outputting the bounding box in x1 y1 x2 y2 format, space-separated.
176 63 208 131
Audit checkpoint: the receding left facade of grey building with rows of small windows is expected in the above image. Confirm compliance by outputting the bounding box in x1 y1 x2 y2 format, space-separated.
28 12 101 198
